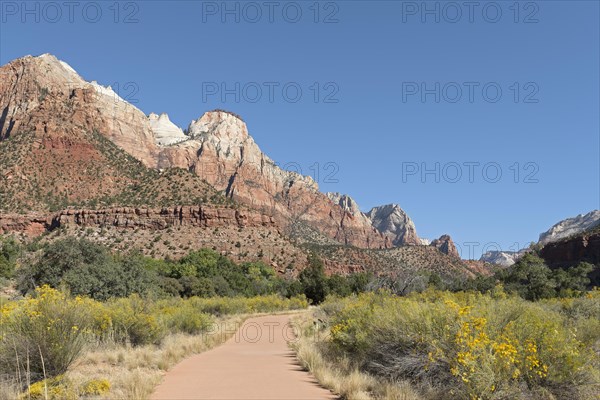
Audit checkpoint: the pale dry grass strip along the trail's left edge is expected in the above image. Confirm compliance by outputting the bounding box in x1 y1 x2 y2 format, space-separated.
66 316 245 400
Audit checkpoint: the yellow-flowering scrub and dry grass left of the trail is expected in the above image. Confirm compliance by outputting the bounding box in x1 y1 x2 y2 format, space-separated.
0 286 308 399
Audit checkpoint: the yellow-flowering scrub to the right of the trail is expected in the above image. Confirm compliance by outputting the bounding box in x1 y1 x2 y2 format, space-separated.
322 290 600 399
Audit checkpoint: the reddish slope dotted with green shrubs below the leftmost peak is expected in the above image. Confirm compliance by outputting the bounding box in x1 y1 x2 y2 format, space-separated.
0 131 234 213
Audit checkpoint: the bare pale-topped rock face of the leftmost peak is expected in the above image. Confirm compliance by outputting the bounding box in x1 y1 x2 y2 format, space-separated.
0 54 158 167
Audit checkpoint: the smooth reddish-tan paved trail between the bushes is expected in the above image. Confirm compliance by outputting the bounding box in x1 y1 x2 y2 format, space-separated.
152 315 337 400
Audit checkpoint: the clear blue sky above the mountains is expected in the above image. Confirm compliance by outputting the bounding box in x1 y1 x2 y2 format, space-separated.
0 1 600 258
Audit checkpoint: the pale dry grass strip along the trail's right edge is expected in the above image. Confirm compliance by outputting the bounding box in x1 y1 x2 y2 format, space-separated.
290 313 422 400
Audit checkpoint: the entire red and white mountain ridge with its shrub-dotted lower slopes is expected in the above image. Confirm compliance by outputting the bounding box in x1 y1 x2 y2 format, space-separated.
0 54 478 273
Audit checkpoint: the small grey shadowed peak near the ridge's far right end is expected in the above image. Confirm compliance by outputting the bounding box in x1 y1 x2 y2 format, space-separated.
366 204 422 246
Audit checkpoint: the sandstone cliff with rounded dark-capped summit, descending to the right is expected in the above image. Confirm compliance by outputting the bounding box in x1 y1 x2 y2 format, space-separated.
159 111 391 248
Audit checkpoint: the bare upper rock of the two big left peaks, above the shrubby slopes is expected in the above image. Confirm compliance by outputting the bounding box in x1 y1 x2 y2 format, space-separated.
0 54 391 248
